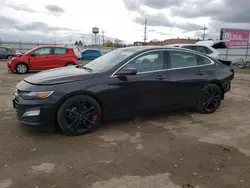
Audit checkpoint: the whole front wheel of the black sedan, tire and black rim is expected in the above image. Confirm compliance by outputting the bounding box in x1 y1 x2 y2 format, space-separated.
57 95 101 136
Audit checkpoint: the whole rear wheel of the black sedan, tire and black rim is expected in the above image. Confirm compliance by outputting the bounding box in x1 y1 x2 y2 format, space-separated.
197 84 222 114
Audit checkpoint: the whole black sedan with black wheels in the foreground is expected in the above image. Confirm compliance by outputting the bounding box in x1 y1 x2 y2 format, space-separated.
13 46 234 135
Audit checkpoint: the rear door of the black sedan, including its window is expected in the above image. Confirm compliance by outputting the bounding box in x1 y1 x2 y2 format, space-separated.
165 50 214 106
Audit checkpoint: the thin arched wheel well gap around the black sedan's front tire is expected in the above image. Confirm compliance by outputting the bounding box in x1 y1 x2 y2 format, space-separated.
54 91 103 128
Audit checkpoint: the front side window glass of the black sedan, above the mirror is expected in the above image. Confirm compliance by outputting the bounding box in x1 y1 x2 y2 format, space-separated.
124 52 164 72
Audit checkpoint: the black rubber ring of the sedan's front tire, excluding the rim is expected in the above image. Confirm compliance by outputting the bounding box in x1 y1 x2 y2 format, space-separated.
57 95 101 136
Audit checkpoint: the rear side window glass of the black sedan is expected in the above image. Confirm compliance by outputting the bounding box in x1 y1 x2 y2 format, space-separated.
169 51 211 68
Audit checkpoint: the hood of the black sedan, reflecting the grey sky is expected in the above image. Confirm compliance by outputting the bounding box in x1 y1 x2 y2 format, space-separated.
24 66 95 85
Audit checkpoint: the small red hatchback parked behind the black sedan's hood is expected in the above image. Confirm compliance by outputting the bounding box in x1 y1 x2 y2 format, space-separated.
8 46 79 74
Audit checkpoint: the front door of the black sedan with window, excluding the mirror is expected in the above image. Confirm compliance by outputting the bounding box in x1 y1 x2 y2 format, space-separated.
102 50 171 114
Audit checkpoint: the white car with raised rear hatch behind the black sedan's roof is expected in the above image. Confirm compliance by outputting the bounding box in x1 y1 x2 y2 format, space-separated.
166 40 227 60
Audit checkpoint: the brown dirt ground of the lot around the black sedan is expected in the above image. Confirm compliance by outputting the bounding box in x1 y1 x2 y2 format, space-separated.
0 61 250 188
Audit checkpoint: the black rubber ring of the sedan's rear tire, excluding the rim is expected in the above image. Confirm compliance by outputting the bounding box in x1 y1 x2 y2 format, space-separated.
197 84 222 114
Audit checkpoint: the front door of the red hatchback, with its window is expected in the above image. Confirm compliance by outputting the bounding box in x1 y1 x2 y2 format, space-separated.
29 47 55 70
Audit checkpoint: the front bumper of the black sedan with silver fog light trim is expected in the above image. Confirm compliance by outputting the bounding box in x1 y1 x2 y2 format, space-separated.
12 98 55 127
